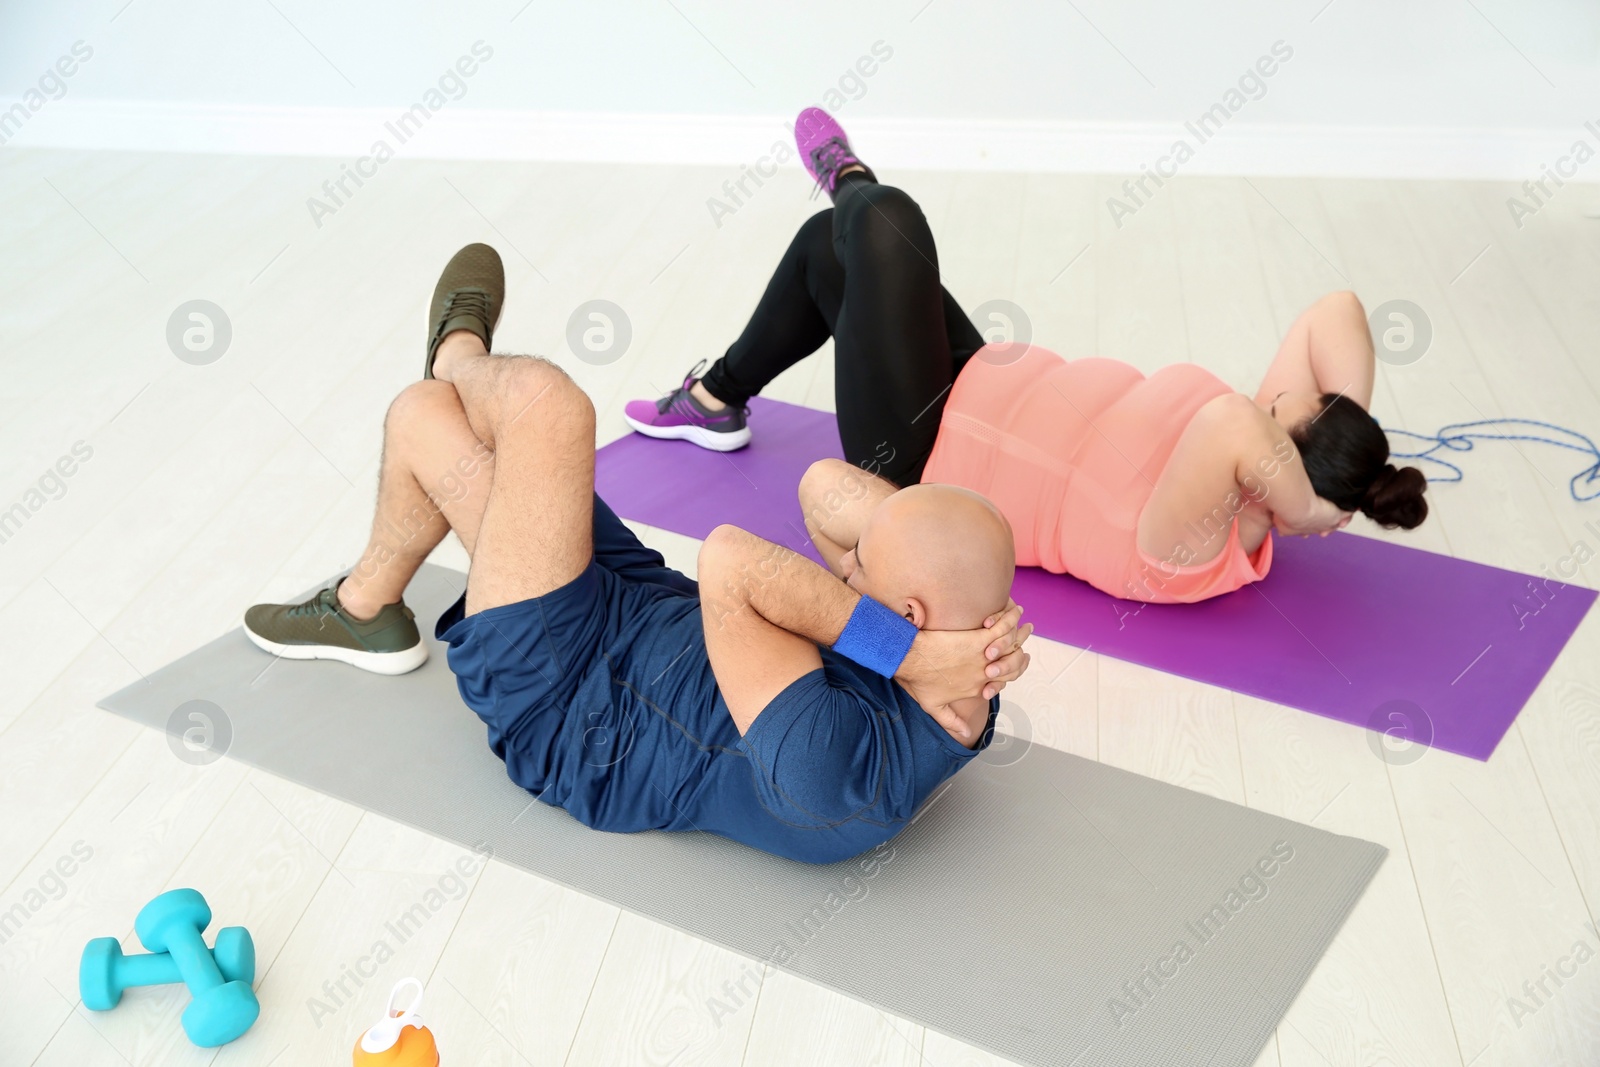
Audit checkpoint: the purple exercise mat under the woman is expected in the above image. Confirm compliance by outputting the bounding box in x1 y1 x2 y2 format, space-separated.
595 397 1595 760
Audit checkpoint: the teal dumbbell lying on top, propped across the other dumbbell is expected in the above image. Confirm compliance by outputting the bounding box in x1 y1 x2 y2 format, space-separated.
133 889 261 1048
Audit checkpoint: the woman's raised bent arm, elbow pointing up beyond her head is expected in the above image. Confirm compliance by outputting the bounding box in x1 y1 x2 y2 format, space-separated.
1256 291 1376 408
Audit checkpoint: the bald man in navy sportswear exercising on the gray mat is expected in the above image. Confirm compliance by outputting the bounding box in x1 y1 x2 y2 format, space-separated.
245 245 1032 862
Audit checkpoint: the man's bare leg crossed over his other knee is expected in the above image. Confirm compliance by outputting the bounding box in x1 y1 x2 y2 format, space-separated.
434 331 595 614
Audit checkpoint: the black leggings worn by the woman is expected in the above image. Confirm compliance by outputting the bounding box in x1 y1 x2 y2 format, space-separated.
701 174 984 485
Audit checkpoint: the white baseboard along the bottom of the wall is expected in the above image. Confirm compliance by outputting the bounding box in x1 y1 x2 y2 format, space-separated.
5 99 1600 182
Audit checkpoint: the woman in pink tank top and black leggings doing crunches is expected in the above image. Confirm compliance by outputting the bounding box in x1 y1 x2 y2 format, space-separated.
626 109 1427 603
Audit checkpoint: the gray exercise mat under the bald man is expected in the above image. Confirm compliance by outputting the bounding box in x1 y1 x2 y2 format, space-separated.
101 566 1386 1067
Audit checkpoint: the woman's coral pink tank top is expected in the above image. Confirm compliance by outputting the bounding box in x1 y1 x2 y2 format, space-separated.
922 346 1272 603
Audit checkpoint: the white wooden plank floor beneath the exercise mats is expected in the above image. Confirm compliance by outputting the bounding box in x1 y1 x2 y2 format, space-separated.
0 150 1600 1067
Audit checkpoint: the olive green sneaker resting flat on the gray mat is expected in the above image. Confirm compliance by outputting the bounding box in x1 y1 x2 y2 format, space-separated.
245 584 427 675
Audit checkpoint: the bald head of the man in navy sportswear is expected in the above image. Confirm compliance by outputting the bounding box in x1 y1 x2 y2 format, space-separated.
848 485 1016 630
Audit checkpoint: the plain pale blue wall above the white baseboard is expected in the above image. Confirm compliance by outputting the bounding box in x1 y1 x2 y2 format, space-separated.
0 0 1600 130
